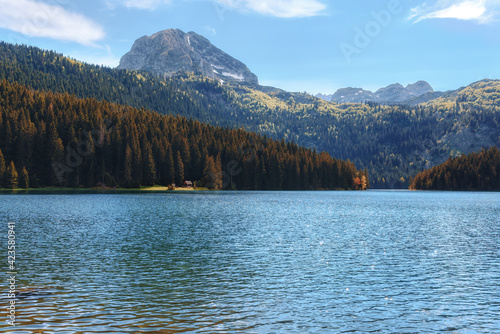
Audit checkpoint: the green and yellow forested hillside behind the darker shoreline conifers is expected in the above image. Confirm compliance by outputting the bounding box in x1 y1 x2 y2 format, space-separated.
0 43 500 188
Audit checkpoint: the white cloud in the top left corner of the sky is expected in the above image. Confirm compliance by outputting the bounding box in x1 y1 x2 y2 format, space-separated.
0 0 105 45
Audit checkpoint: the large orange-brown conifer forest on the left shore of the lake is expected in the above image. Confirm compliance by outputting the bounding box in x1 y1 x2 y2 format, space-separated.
0 80 367 190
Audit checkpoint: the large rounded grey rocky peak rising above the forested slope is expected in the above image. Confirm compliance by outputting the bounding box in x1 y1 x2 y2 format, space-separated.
118 29 259 85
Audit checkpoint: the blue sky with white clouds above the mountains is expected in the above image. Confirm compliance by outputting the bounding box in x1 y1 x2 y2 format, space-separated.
0 0 500 94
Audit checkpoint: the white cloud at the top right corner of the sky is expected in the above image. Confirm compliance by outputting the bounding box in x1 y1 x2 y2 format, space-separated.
409 0 498 23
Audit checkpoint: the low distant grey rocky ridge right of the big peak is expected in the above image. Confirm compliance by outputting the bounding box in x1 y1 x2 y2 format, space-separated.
316 81 434 103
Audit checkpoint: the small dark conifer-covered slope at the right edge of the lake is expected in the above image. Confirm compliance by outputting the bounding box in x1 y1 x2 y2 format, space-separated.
410 147 500 191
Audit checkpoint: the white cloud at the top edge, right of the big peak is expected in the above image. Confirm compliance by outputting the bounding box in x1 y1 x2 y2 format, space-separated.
216 0 326 18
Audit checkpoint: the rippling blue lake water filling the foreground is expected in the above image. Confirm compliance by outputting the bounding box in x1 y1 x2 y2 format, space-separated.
0 191 500 333
